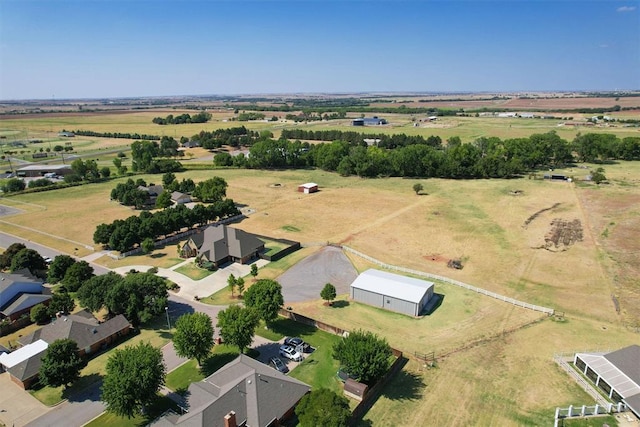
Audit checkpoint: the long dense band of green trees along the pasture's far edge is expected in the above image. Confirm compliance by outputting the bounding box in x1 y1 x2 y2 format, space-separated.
236 132 640 179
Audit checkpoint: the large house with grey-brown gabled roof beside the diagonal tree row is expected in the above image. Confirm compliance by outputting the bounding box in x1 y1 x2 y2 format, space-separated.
181 225 264 267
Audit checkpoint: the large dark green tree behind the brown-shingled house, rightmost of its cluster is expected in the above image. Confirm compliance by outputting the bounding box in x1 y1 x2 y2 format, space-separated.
105 273 169 326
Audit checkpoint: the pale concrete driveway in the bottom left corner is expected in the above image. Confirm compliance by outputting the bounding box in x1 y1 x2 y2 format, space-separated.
0 372 49 427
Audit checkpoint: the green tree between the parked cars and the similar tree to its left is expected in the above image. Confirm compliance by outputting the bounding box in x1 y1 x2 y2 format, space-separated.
217 305 260 353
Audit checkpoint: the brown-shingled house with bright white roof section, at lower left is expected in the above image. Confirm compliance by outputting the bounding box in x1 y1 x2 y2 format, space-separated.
0 310 132 389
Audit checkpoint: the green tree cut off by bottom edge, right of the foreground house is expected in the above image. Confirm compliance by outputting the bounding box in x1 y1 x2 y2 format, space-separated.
296 388 351 427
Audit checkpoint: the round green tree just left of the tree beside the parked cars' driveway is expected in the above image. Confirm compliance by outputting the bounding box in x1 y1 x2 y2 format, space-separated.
173 313 213 366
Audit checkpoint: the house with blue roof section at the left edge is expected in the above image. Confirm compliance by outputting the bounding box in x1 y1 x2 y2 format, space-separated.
0 269 51 321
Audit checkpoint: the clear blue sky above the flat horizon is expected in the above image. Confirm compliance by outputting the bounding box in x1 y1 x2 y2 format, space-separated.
0 0 640 100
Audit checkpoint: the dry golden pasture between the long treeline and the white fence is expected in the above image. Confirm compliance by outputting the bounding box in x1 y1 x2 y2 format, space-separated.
0 164 633 320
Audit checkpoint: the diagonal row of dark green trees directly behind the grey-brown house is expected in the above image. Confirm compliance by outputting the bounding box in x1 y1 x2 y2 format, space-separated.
93 199 239 252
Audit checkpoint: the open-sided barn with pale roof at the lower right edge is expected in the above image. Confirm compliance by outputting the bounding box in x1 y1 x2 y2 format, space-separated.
573 344 640 417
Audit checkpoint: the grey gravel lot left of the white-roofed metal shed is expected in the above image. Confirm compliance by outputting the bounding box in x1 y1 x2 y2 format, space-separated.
277 246 358 307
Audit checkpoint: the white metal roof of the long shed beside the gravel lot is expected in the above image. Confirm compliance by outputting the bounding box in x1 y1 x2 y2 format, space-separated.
351 269 434 303
